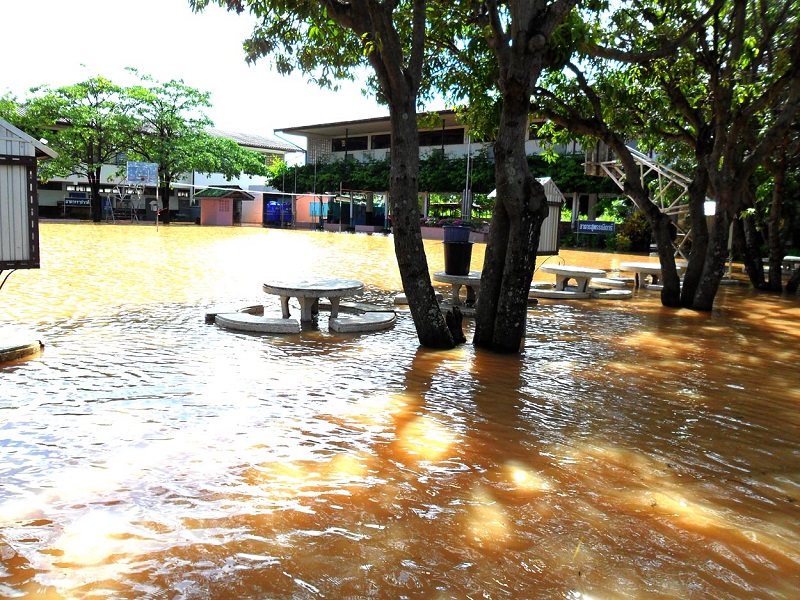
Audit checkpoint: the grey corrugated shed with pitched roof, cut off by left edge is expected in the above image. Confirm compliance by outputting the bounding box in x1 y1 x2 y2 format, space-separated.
0 119 58 271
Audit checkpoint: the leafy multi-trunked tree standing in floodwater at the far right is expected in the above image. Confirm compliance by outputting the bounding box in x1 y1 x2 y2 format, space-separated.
542 0 800 310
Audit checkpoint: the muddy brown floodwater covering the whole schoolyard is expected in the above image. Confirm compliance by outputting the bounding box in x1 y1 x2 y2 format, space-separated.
0 224 800 599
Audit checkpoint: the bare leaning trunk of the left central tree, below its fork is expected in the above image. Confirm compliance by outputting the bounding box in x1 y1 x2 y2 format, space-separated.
389 99 455 348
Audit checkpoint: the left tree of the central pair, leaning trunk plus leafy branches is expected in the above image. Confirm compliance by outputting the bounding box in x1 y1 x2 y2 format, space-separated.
189 0 454 347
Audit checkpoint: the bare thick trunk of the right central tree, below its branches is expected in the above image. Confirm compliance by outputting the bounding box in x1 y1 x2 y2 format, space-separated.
473 94 547 353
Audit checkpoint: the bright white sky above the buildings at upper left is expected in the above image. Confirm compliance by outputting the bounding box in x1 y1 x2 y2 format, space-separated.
0 0 388 142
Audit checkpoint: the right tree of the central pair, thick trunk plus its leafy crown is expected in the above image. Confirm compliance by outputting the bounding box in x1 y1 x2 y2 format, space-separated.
418 0 578 352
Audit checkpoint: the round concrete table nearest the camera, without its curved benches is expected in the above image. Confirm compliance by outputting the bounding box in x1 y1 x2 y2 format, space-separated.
262 277 364 322
